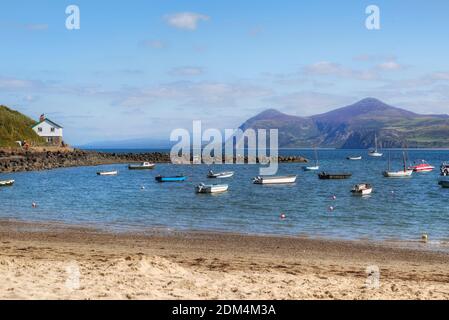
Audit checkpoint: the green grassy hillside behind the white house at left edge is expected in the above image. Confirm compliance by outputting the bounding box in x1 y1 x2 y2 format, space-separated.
0 105 45 147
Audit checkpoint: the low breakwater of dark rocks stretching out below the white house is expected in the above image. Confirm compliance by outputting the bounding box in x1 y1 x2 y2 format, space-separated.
0 150 307 172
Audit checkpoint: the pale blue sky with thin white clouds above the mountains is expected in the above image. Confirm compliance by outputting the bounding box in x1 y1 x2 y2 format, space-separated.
0 0 449 144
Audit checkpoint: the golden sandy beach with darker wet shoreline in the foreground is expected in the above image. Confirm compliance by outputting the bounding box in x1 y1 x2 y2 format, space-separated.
0 221 449 299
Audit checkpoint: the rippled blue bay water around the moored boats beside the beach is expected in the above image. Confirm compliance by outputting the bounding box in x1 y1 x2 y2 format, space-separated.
0 150 449 241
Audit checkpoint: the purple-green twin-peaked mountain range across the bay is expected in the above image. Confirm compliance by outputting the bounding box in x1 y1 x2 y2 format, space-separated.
240 98 449 149
